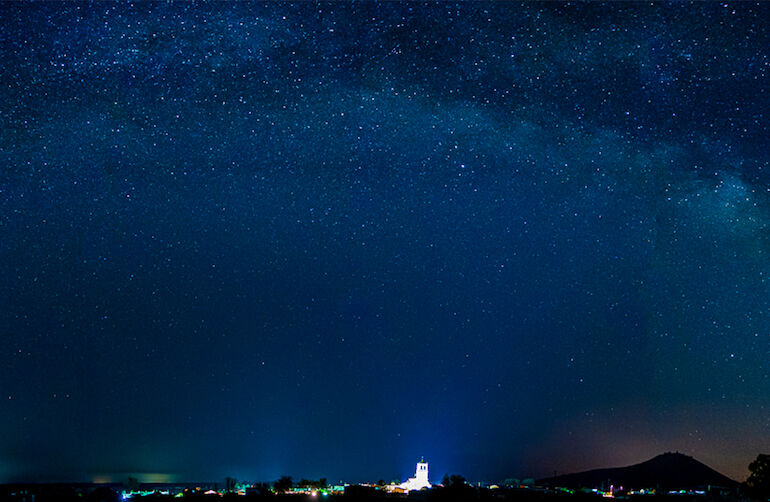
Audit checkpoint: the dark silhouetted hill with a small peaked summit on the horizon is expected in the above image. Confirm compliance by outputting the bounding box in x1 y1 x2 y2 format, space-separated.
538 453 738 490
